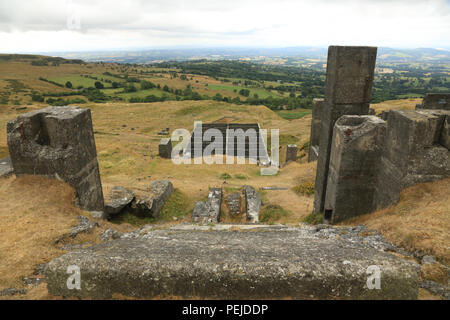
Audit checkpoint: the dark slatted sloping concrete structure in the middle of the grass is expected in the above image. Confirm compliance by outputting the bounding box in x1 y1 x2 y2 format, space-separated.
185 123 270 163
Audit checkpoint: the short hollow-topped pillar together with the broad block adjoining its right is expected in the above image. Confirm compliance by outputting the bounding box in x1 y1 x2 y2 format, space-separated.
323 110 450 223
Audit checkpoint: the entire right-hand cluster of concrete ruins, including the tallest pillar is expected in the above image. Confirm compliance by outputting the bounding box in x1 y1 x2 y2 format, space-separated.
308 47 450 223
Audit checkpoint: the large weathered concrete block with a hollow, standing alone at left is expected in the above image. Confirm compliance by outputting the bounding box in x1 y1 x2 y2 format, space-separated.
7 107 104 211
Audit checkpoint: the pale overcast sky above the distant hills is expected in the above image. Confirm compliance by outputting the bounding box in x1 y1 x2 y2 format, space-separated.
0 0 450 52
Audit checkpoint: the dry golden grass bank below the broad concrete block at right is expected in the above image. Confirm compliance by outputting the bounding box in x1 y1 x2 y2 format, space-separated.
347 178 450 264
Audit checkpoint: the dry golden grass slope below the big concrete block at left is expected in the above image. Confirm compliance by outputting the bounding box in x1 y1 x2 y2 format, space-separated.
0 176 80 288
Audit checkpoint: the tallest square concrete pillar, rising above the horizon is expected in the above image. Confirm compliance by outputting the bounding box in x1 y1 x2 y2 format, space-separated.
314 46 377 212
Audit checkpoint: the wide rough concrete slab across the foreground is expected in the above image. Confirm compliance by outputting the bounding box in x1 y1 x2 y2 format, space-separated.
45 227 418 299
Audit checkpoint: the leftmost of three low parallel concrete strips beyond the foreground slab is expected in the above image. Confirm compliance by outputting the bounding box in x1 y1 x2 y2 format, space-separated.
191 188 222 224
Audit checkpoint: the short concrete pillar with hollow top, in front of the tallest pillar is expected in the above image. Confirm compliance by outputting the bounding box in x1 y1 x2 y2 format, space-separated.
324 116 386 223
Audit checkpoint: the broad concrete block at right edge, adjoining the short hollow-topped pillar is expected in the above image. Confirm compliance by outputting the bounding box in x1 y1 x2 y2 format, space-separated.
374 110 450 208
